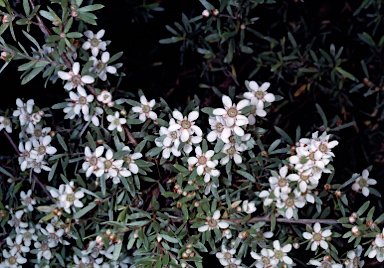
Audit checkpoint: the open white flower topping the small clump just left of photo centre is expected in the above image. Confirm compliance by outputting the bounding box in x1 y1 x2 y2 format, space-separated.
168 110 203 142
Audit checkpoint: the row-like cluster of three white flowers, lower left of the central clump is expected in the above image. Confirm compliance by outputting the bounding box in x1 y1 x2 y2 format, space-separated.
82 146 143 184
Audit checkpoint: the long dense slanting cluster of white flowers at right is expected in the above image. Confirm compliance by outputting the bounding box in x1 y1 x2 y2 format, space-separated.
259 132 338 219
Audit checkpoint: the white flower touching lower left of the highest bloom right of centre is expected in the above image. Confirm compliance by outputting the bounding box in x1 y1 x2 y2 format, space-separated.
213 95 249 133
